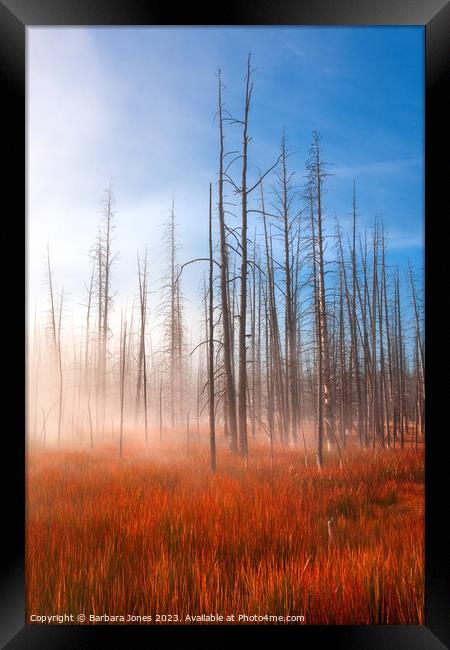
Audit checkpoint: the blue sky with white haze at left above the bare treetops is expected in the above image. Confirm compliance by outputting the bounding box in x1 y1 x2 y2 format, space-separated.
27 27 424 334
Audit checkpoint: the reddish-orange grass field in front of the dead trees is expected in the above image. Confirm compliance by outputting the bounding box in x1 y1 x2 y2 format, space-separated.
26 446 424 624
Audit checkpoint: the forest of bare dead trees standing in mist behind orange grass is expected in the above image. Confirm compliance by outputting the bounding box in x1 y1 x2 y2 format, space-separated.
27 56 424 471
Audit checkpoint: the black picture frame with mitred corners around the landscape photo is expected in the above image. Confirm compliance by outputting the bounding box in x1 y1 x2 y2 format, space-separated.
0 0 450 650
